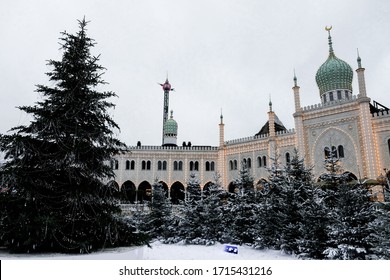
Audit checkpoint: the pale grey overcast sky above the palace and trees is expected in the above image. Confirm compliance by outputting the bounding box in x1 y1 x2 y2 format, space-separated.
0 0 390 146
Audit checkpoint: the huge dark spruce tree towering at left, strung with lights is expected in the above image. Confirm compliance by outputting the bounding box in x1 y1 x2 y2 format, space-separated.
0 19 145 253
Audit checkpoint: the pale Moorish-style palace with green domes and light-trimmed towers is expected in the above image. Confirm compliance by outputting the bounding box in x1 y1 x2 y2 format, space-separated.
112 28 390 202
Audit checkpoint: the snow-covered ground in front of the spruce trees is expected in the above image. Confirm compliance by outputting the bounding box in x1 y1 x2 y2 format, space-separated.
0 242 296 260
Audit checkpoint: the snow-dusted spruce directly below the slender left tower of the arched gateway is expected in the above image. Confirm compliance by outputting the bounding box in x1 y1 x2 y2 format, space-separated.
280 149 328 259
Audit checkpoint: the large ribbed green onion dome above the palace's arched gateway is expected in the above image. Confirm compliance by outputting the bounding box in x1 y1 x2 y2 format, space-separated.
316 30 353 96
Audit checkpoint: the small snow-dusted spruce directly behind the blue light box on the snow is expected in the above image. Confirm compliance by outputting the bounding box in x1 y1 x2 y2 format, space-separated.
223 162 257 244
